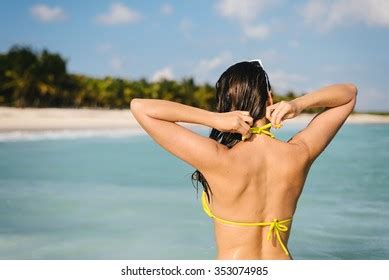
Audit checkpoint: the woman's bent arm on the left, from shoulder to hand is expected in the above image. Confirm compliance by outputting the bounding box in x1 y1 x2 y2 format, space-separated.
130 98 252 171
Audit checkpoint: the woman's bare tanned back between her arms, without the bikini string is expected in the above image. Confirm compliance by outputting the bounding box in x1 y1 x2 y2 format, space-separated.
202 134 309 259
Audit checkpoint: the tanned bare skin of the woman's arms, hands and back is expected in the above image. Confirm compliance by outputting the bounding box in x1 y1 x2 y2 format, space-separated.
131 83 357 259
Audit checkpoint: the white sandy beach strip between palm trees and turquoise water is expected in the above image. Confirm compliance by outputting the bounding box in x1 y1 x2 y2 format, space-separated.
0 107 389 132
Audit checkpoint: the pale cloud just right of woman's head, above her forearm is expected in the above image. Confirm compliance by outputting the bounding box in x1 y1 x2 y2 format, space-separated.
268 70 308 93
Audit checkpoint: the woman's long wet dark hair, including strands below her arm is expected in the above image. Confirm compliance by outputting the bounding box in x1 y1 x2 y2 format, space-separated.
192 61 271 201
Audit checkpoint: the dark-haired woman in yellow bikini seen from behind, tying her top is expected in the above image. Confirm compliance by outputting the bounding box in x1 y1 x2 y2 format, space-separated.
131 61 357 259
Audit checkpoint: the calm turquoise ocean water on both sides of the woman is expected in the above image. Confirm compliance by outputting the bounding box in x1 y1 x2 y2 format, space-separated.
0 124 389 259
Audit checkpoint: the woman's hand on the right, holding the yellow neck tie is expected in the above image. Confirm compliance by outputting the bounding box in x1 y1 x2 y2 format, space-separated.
266 100 302 127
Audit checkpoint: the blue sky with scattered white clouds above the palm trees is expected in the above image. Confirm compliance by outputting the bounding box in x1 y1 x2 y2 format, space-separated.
0 0 389 111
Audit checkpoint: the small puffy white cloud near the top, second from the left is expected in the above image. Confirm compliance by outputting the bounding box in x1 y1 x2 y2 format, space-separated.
96 3 142 25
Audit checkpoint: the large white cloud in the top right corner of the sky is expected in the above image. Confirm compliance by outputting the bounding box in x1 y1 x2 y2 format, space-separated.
302 0 389 31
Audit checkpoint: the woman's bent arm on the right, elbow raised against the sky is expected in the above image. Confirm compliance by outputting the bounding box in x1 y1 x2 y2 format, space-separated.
270 84 358 163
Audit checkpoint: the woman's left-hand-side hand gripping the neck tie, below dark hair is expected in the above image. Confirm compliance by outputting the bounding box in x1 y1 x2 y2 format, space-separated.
214 111 253 135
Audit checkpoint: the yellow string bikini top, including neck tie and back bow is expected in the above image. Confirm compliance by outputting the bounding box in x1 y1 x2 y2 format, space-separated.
201 123 293 256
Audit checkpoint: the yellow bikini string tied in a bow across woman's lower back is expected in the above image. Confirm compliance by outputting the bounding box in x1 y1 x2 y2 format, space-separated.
201 191 293 256
